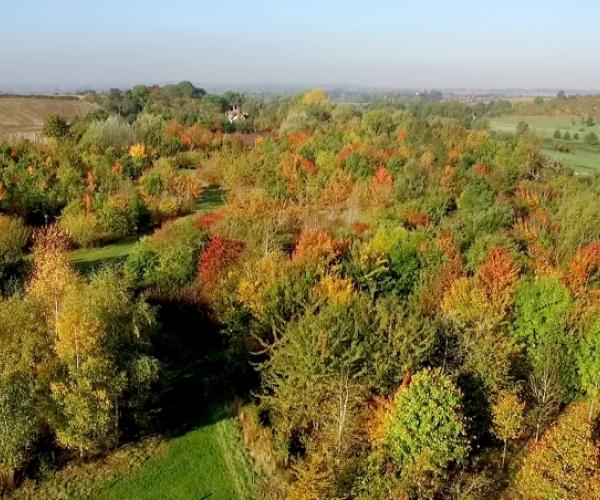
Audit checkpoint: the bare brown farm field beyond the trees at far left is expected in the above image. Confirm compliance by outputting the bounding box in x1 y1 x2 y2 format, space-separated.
0 97 97 138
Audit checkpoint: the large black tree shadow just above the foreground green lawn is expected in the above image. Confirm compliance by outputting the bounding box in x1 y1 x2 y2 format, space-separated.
139 303 249 438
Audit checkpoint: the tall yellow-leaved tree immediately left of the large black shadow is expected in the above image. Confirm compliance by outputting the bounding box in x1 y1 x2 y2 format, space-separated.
51 271 158 453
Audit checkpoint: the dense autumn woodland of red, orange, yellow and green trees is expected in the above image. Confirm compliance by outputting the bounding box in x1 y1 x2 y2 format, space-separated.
0 82 600 500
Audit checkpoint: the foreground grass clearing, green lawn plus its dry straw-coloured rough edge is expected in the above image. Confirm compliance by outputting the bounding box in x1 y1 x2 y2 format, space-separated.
9 410 255 500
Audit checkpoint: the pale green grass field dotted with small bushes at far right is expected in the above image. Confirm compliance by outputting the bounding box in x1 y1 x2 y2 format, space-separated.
490 115 600 173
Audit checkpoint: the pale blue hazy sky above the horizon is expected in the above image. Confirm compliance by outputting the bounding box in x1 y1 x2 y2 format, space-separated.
0 0 600 89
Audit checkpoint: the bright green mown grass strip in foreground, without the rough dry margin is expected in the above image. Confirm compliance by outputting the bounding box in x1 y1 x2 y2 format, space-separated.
94 406 252 500
